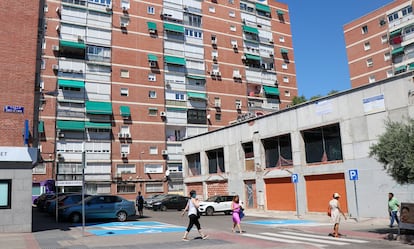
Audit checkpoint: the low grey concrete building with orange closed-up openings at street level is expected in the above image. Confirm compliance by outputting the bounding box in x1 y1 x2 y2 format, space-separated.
182 73 414 218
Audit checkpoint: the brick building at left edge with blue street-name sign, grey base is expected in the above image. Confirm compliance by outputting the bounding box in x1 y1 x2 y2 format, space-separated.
0 1 43 233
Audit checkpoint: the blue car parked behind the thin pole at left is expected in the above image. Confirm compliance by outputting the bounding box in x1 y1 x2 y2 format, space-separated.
58 195 136 223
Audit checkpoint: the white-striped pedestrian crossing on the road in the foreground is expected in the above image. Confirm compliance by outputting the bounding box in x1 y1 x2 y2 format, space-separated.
242 231 368 248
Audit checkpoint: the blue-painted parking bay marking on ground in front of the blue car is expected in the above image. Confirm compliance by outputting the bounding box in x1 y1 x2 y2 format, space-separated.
87 221 186 236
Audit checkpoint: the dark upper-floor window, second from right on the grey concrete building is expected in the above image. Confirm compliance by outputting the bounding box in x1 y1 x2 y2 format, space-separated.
262 134 293 168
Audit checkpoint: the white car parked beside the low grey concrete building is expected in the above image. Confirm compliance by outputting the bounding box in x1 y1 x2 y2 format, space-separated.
198 195 233 215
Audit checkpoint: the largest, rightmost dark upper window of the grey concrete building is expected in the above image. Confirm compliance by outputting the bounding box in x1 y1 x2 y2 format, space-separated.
302 124 342 163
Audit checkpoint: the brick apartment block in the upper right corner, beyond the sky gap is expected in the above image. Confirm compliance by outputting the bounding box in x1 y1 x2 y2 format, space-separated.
344 0 414 87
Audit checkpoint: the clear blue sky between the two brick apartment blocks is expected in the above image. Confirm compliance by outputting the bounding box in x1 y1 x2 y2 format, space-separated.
284 0 393 99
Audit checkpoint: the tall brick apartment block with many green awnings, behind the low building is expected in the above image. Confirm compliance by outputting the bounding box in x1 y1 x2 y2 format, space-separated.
33 0 297 199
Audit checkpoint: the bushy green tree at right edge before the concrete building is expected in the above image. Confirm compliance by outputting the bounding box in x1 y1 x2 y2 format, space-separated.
369 118 414 184
